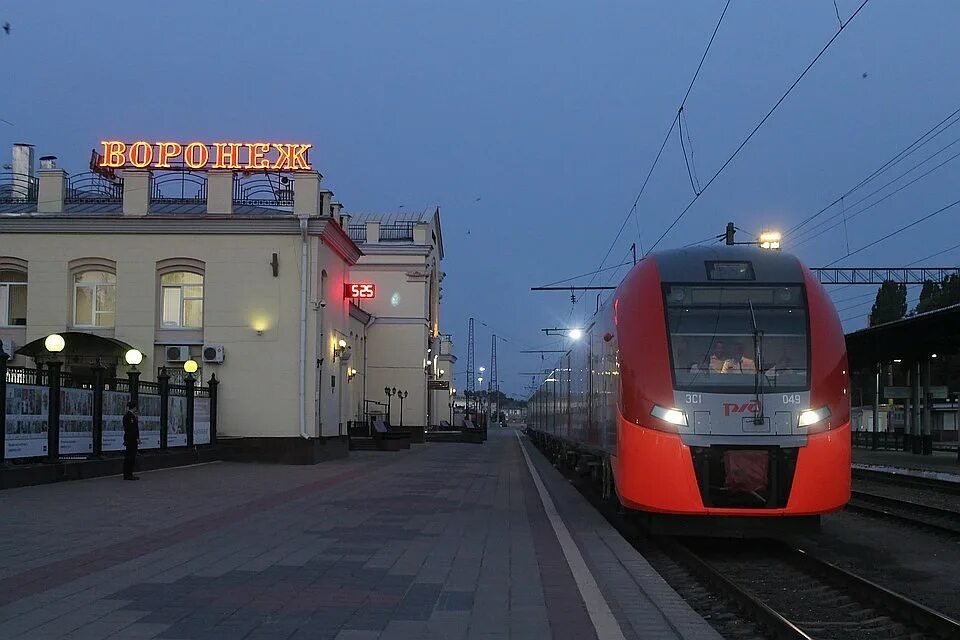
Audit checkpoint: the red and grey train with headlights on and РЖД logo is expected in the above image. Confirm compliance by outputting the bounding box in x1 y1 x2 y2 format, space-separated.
528 246 850 535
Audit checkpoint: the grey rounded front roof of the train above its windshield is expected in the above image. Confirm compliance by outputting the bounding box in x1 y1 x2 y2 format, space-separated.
650 245 803 284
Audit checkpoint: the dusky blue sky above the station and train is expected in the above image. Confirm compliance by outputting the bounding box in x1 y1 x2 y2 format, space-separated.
0 0 960 396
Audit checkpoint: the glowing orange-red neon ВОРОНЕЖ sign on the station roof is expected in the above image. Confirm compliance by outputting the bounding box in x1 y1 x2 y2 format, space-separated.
100 140 313 171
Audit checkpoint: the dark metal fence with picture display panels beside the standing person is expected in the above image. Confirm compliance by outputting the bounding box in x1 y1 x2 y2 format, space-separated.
0 355 219 463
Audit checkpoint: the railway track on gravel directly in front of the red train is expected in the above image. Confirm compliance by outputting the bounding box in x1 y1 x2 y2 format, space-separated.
662 539 960 640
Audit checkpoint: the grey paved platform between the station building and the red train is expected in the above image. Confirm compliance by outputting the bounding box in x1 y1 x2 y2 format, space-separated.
0 429 718 640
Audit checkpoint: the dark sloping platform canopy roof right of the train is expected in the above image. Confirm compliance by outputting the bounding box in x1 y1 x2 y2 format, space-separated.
846 304 960 369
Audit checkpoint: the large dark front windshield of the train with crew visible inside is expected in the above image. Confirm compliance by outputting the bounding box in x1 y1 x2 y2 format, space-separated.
664 285 809 393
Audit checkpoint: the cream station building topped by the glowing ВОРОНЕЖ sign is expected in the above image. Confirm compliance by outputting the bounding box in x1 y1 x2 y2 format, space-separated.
0 142 452 463
